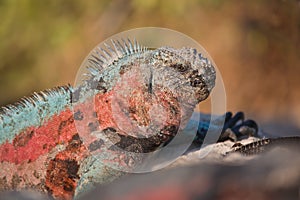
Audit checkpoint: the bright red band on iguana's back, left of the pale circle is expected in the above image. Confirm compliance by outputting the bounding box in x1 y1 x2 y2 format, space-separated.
0 109 76 164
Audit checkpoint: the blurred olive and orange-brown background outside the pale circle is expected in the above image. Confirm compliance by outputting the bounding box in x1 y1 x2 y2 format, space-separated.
0 0 300 135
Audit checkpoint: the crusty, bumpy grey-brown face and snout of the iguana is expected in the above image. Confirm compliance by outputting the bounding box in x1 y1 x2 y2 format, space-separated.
153 47 216 103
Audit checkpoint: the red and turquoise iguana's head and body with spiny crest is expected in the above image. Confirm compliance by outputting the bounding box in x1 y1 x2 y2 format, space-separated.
0 41 215 199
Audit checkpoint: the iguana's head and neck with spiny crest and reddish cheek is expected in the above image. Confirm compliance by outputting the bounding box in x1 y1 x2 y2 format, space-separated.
74 40 216 152
